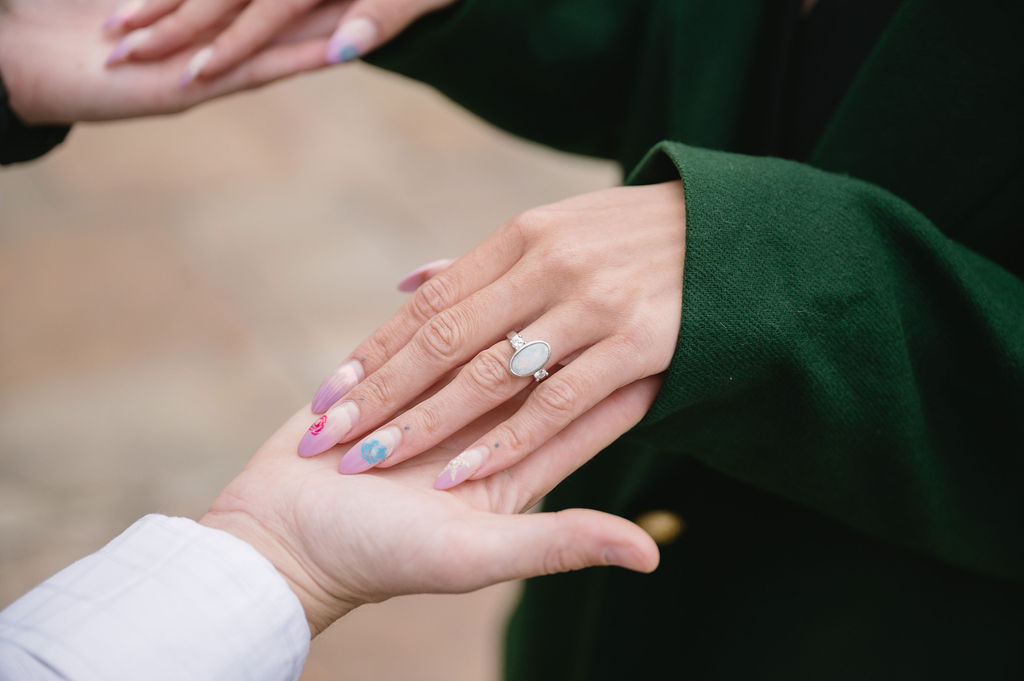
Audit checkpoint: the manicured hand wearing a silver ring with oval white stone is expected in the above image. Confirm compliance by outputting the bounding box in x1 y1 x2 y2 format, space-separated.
299 181 685 487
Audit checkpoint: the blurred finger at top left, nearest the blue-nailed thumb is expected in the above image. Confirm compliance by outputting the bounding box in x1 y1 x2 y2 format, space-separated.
193 0 331 79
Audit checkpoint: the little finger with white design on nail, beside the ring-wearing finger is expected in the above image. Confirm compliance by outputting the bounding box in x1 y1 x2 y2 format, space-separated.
434 338 640 490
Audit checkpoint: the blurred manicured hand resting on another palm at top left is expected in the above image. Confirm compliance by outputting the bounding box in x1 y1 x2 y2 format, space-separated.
105 0 455 82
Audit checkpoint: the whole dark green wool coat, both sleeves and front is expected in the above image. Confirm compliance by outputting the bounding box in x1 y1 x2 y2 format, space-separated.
375 0 1024 681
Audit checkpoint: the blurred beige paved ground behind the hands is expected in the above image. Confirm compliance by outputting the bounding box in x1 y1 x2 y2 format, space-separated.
0 65 617 681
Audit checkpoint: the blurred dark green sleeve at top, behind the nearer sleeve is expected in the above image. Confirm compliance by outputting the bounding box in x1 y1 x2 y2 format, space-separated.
368 0 765 160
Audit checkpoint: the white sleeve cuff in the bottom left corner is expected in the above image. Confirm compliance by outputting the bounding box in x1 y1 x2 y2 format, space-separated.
0 515 309 681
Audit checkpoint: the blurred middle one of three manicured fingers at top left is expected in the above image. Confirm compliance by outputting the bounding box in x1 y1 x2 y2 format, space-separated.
111 0 246 65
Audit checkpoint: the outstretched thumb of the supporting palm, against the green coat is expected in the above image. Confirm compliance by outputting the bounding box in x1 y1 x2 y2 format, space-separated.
473 509 658 586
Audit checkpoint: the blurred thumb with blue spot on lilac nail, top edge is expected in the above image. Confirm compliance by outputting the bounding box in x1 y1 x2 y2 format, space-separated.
327 0 454 63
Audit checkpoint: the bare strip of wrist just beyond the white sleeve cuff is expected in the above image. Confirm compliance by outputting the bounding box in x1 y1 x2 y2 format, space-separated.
199 510 357 638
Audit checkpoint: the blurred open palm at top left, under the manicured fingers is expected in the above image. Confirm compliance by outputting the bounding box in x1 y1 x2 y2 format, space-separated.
0 0 341 124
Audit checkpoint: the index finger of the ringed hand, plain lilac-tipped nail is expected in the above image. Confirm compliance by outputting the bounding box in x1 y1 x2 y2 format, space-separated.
313 229 522 414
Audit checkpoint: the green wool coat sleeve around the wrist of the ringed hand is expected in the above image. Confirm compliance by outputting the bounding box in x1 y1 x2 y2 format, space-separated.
631 142 1024 580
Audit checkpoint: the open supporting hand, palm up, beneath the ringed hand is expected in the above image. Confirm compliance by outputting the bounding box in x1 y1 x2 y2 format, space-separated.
201 379 658 636
